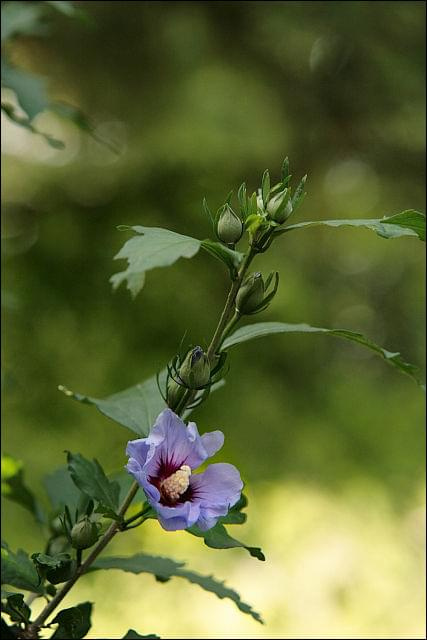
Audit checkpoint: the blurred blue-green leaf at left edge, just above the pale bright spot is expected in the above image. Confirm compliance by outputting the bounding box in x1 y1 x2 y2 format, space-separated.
1 59 49 120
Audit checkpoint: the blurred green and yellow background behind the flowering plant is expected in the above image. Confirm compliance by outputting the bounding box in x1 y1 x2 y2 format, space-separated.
2 2 425 638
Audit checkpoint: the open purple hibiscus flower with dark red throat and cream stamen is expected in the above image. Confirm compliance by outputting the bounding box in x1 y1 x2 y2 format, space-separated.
126 409 243 531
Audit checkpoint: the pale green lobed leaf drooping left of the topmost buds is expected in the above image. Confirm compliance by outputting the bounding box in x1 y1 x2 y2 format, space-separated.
110 226 201 297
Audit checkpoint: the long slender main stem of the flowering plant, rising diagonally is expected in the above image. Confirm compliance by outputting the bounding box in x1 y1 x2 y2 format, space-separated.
28 248 255 638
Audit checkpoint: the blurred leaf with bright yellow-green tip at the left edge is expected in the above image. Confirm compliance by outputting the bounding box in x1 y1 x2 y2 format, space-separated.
1 455 46 523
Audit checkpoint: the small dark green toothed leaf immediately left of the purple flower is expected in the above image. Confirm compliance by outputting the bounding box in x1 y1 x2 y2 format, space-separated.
67 452 120 512
